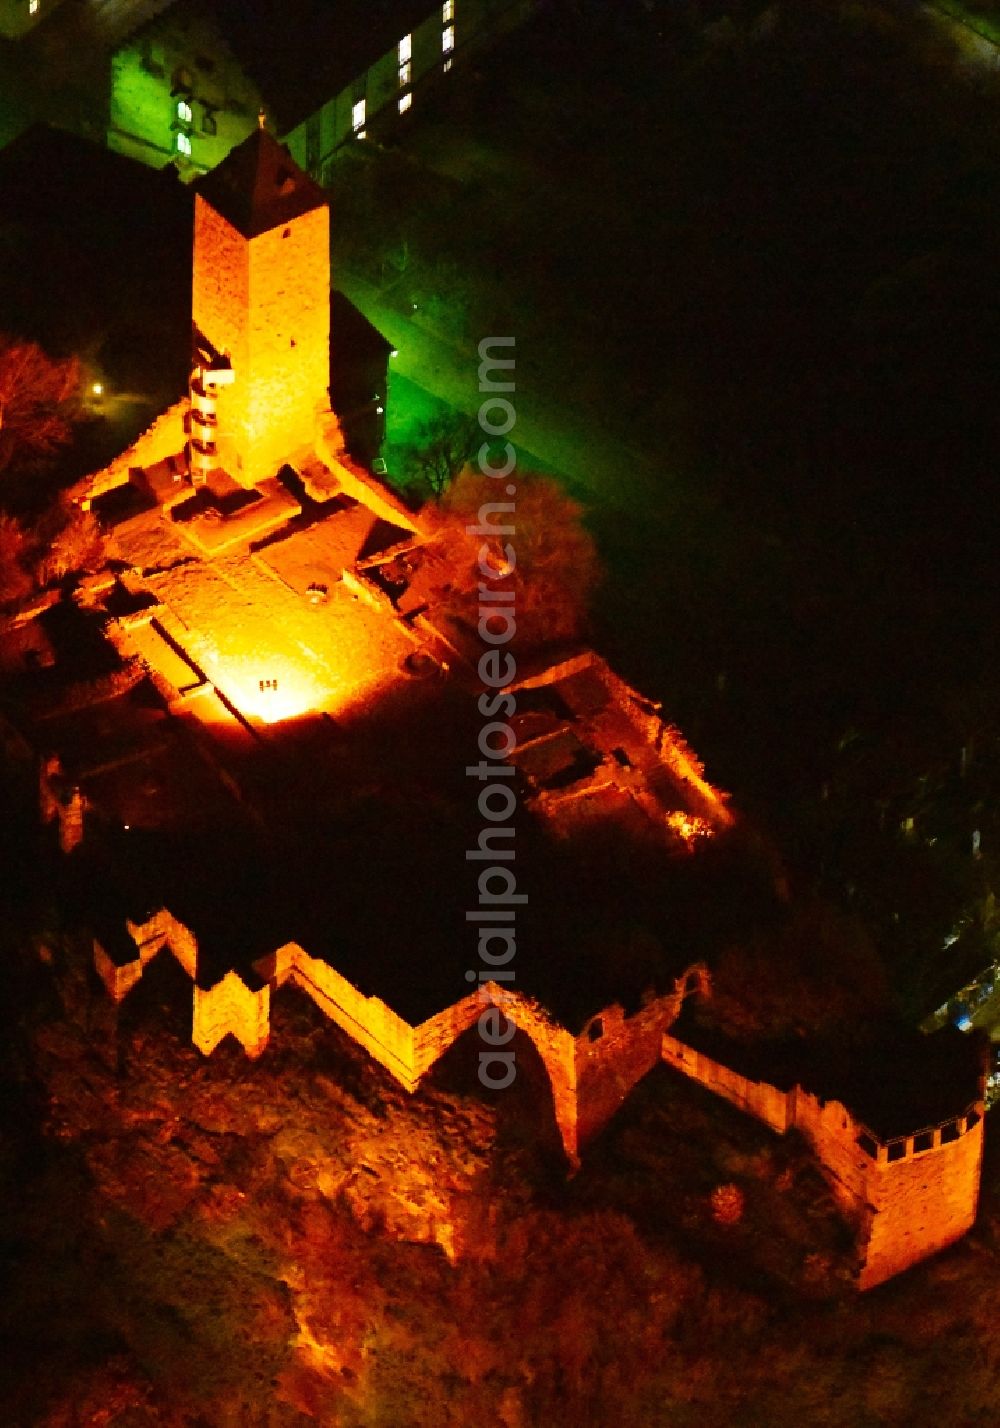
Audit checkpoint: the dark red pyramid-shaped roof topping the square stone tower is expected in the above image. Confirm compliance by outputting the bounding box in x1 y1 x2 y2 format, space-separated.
194 126 327 238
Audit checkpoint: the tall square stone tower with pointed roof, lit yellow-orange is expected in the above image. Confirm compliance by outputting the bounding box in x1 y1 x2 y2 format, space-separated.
191 119 330 487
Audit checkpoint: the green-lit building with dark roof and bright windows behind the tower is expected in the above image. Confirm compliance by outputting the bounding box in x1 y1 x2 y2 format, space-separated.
105 0 536 181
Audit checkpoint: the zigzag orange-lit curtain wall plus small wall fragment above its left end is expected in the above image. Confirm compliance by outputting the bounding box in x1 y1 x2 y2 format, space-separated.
41 753 984 1289
